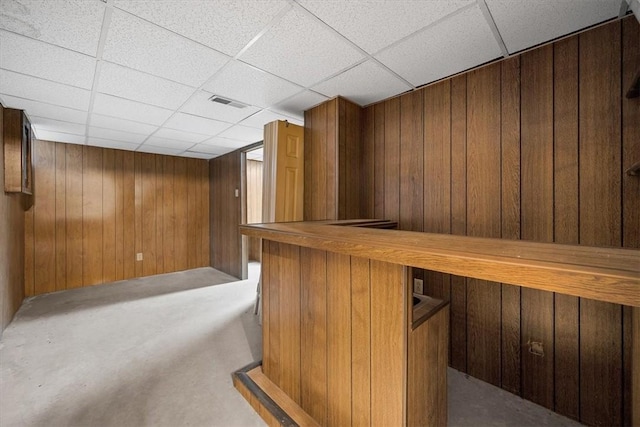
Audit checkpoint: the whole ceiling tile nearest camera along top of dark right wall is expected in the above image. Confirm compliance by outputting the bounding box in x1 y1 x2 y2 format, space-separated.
375 5 502 86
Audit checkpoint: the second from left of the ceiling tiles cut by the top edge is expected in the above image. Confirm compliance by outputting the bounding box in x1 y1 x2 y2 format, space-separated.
114 0 289 56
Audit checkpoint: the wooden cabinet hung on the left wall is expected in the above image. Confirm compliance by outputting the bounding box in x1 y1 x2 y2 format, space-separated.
2 108 33 194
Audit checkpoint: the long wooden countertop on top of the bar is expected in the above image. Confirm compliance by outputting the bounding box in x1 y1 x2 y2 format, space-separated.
240 220 640 307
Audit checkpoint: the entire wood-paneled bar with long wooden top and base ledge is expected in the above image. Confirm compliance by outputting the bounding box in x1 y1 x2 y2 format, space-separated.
234 220 640 426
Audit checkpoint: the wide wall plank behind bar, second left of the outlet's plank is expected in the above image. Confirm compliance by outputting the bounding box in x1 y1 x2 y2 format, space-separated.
467 64 501 386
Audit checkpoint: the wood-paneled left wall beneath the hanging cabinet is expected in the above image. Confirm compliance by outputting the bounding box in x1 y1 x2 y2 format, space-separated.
0 105 29 336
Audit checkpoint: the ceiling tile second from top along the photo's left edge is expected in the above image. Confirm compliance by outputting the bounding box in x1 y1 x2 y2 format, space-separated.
0 31 96 89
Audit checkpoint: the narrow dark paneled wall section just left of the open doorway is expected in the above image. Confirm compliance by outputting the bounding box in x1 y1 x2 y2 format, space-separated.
209 151 243 278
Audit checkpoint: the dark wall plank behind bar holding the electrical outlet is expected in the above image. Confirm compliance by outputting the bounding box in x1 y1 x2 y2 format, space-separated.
521 45 554 408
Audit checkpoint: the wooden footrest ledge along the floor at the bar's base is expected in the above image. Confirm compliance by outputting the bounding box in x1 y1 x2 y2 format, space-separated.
232 362 319 427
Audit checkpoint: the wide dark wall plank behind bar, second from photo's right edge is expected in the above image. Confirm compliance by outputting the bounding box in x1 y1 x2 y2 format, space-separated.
579 22 622 425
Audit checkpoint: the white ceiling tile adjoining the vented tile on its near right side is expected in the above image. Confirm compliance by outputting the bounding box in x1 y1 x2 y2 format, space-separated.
204 61 304 107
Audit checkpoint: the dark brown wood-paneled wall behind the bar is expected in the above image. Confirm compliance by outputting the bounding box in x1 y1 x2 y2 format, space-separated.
305 17 640 425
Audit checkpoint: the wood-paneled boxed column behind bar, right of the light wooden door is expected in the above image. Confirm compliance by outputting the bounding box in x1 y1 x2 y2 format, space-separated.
304 97 362 221
